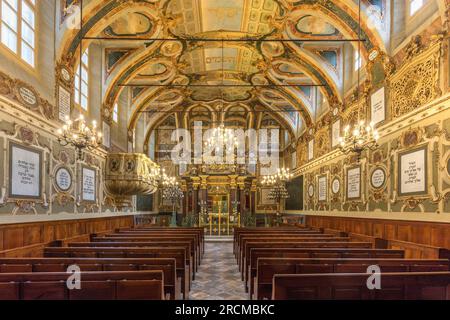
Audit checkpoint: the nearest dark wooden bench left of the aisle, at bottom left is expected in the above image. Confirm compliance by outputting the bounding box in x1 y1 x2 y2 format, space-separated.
0 271 164 300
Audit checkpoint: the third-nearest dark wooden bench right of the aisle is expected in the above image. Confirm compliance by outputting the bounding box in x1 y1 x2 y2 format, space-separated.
244 247 405 292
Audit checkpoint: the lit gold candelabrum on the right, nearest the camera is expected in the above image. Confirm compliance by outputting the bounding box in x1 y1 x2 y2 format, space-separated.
339 121 380 161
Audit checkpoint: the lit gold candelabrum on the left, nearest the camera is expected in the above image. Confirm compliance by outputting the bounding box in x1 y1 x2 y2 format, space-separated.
58 115 102 160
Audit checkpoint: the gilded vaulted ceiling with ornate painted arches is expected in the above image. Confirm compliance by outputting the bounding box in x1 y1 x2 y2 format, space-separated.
59 0 390 141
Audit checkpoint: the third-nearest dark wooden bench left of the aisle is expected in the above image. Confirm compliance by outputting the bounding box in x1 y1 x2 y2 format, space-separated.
44 247 191 299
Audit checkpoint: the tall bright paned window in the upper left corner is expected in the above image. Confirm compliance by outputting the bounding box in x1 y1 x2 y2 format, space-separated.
0 0 36 67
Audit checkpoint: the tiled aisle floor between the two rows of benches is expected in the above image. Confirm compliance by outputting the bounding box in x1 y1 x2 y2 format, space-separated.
189 242 247 300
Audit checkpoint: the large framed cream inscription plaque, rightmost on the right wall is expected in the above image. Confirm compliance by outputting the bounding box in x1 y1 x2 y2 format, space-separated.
398 146 428 196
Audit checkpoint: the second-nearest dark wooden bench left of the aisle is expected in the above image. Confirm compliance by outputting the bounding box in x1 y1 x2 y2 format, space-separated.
0 258 181 300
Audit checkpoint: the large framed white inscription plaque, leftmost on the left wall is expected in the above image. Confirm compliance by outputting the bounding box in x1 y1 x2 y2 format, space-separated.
9 142 42 199
